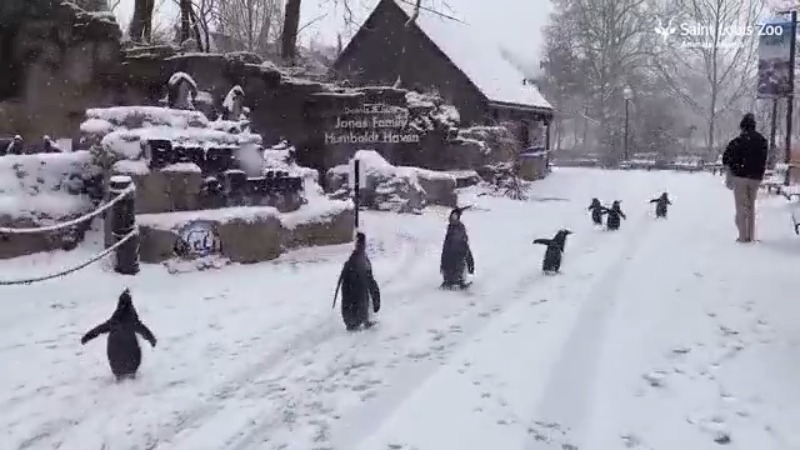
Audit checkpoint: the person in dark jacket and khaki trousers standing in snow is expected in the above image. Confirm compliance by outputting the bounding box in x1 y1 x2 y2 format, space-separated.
722 113 768 242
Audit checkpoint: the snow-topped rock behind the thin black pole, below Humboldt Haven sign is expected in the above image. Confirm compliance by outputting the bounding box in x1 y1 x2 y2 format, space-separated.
326 150 458 213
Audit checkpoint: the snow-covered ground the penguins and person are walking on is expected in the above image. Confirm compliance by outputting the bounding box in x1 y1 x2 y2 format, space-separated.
0 168 800 450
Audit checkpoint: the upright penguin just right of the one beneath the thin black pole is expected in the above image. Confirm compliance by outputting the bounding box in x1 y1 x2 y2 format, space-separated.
439 206 475 289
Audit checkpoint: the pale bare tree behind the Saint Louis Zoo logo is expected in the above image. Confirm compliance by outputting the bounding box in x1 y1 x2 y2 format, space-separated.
654 0 765 152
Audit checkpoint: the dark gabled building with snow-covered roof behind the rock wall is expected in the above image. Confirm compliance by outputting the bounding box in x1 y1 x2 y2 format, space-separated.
333 0 553 148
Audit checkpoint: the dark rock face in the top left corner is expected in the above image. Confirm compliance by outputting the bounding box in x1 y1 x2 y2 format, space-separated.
0 1 121 141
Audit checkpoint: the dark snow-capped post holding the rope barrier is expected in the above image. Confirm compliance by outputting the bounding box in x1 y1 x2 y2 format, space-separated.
109 175 139 275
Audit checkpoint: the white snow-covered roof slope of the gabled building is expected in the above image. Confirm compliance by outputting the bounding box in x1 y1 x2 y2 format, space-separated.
390 0 552 109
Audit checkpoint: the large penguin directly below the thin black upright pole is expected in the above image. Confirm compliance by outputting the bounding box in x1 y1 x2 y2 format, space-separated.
333 233 381 331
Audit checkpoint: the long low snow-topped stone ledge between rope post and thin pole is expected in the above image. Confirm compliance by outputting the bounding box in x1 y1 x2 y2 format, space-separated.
137 199 354 263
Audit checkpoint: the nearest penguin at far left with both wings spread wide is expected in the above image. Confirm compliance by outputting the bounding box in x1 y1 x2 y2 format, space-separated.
81 289 156 382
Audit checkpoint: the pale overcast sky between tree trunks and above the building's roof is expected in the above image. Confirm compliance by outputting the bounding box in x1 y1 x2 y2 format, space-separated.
116 0 551 62
